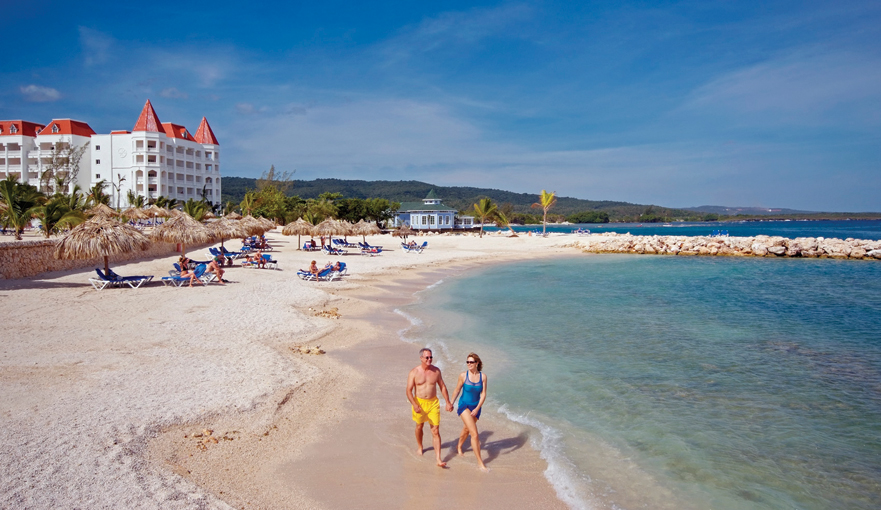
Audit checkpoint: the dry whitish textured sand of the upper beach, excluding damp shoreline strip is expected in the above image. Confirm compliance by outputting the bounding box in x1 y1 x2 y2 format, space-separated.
0 233 576 509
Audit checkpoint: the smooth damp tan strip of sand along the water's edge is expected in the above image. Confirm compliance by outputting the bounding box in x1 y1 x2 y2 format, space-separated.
149 246 567 509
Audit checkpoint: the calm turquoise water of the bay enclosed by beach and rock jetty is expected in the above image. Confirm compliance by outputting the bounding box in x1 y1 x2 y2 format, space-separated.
399 237 881 510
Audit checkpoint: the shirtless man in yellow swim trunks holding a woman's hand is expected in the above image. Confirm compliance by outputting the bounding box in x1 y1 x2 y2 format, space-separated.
407 348 453 467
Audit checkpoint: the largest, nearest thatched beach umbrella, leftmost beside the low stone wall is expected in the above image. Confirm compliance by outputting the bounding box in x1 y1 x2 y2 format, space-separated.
55 216 150 275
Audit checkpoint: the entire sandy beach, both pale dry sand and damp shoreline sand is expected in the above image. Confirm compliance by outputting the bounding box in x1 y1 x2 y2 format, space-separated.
0 231 579 509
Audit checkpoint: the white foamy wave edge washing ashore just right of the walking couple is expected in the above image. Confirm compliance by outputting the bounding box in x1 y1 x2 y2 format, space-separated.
499 404 593 510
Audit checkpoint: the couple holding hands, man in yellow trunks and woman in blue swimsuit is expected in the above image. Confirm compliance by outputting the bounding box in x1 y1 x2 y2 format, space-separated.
407 348 489 471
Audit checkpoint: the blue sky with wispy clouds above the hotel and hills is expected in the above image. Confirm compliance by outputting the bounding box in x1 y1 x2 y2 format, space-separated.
0 0 881 212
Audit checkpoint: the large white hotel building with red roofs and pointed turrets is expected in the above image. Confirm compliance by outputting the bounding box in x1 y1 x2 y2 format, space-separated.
0 100 220 206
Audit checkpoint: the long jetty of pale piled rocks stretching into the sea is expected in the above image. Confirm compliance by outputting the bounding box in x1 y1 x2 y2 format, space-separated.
572 233 881 260
